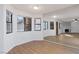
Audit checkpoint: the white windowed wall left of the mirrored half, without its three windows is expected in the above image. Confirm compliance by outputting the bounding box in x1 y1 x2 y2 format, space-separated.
4 5 43 53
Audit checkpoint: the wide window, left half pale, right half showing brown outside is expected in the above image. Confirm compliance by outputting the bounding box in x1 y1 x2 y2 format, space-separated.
17 16 32 32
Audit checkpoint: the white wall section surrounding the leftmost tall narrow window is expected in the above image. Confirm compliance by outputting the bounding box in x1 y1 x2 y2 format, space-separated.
4 5 16 53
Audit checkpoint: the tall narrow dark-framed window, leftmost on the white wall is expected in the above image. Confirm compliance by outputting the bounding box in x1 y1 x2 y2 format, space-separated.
6 10 13 34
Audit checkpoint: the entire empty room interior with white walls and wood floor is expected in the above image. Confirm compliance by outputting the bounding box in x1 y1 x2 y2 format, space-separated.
0 4 79 54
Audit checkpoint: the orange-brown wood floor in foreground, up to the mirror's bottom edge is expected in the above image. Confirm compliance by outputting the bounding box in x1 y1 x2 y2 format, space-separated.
8 37 79 54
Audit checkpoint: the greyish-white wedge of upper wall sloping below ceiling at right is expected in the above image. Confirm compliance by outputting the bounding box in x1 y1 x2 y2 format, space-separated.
45 4 79 21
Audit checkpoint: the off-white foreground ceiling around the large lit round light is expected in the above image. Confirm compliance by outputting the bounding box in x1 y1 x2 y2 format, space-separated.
12 4 73 14
